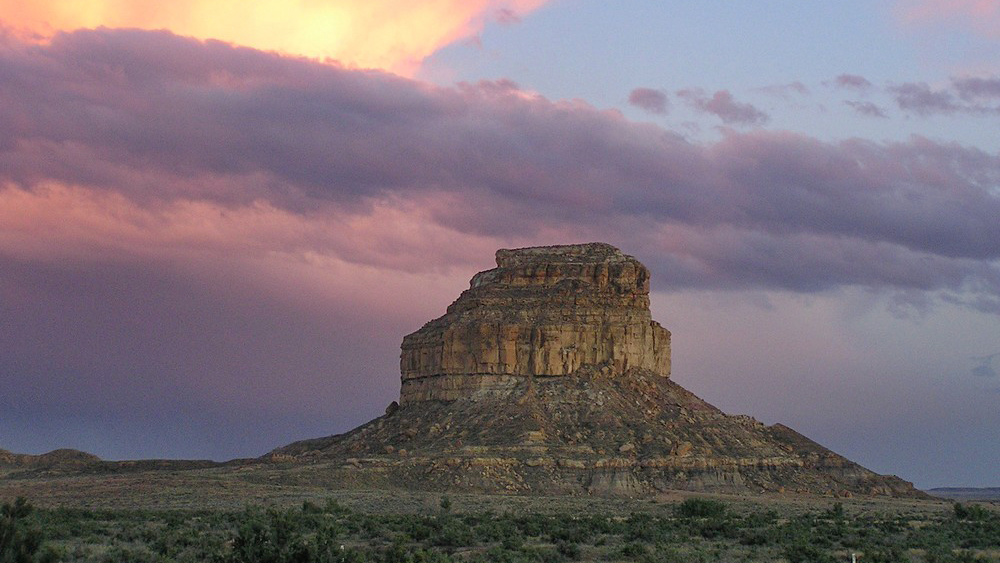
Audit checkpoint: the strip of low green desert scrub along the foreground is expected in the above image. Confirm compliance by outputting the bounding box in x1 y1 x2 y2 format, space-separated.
0 497 1000 563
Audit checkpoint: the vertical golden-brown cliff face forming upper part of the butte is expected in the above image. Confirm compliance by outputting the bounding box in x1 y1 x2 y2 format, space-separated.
400 243 670 404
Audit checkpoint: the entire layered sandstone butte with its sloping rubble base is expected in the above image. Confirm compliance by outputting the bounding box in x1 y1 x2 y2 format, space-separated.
270 243 925 497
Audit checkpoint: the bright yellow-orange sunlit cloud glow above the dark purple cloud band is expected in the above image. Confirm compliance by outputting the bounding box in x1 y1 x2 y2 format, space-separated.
0 0 545 75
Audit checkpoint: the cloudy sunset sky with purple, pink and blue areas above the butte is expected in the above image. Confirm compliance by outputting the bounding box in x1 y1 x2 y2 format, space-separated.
0 0 1000 488
